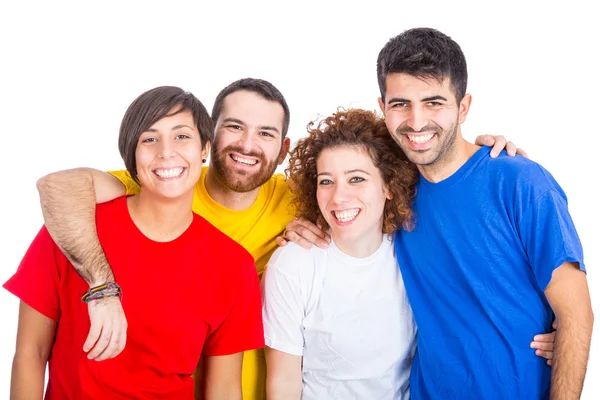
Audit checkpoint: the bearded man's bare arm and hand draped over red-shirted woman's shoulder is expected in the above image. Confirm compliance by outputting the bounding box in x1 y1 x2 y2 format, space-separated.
37 168 127 361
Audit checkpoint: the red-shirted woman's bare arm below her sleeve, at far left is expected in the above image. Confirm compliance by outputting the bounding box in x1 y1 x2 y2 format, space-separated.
10 301 56 400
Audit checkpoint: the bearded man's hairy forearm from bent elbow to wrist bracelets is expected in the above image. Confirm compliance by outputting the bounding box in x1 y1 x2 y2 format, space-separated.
37 169 114 286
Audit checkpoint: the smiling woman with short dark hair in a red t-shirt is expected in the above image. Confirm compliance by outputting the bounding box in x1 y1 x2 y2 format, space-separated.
4 86 264 400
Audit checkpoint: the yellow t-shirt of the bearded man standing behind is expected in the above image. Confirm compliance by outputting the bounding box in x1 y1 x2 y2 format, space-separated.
110 167 295 400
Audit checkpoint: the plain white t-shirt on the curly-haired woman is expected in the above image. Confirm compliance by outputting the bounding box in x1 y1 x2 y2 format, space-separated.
263 235 416 400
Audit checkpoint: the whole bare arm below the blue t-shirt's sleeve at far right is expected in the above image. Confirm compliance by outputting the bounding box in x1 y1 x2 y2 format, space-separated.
545 262 594 400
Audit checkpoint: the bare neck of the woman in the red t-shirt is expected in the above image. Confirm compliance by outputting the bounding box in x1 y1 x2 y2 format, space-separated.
127 188 194 242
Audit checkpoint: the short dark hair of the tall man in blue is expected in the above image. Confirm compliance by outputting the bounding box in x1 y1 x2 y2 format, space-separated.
377 28 468 102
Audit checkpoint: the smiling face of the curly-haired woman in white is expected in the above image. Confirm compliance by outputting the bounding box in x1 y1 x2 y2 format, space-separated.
317 146 389 246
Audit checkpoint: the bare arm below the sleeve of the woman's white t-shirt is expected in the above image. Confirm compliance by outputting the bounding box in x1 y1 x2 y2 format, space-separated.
265 347 302 400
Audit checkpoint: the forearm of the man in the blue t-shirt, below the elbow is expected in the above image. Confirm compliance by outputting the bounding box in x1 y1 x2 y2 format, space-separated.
550 312 594 400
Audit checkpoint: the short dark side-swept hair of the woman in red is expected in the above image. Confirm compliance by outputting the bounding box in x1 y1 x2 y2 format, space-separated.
119 86 214 183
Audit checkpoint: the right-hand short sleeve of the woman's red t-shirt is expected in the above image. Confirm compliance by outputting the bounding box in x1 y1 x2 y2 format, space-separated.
202 254 265 356
